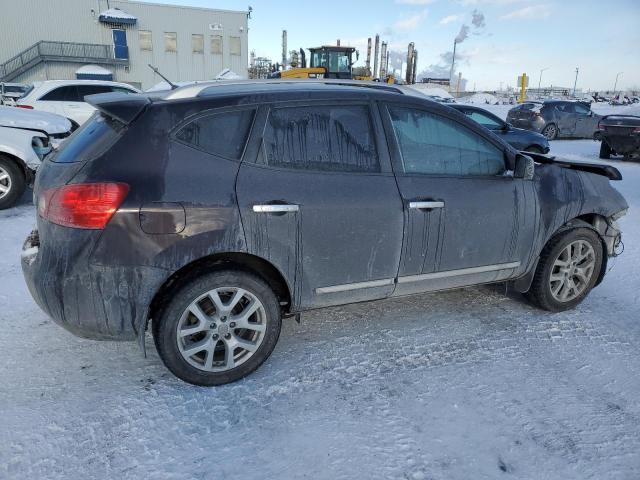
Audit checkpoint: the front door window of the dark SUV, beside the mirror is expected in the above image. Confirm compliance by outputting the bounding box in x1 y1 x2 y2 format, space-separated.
390 108 505 176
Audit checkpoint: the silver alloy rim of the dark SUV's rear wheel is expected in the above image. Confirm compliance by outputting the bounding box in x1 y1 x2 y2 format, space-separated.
176 287 267 372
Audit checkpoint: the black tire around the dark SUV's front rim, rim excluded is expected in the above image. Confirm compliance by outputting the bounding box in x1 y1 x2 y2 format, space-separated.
525 228 604 312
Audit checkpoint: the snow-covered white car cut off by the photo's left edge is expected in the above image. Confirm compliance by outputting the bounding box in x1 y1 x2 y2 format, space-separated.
0 106 71 210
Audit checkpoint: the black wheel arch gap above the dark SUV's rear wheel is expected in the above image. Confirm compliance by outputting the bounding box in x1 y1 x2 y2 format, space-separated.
146 252 292 331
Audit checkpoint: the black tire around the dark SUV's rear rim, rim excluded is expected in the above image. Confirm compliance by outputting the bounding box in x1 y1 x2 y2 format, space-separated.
152 270 282 387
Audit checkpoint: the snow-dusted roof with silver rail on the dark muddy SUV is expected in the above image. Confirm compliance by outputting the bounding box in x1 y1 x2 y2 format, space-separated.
162 79 405 100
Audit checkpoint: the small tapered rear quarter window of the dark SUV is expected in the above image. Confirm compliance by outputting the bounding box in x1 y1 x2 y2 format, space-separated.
175 110 255 160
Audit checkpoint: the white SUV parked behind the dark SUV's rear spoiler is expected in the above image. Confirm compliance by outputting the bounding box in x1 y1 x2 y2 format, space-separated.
16 80 140 127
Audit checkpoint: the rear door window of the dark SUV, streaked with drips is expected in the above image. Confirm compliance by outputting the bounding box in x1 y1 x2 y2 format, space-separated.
258 105 380 173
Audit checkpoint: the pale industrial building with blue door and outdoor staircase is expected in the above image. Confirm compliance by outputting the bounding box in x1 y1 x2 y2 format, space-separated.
0 0 249 89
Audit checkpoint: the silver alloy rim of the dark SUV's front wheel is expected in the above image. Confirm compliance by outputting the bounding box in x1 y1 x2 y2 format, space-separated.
549 240 596 303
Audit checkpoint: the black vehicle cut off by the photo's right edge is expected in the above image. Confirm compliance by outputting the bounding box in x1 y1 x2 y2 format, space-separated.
596 115 640 159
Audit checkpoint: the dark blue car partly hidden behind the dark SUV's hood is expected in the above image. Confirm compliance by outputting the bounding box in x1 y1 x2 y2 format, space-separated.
450 104 549 153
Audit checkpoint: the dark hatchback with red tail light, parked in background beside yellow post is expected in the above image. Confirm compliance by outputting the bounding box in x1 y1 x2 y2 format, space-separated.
507 100 602 140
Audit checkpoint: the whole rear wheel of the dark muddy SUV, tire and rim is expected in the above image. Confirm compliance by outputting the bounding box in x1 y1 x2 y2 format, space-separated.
153 270 282 386
